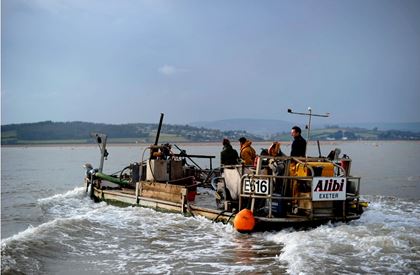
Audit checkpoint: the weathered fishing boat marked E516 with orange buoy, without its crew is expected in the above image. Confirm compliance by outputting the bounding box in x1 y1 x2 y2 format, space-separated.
84 110 366 232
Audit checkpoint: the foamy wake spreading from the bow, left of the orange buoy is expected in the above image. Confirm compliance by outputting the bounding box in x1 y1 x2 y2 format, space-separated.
1 188 266 274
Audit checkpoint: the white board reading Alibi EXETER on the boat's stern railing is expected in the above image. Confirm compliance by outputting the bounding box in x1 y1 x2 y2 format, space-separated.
312 177 347 201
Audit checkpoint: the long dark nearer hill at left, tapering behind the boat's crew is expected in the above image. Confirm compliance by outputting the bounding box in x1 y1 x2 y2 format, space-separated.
1 121 261 144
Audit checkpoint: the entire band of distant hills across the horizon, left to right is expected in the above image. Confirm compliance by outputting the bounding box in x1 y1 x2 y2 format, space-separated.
1 120 420 145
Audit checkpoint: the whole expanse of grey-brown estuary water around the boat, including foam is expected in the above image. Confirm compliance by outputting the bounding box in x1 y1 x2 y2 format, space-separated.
1 141 420 274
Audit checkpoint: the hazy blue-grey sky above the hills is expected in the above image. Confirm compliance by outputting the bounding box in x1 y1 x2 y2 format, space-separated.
1 0 420 125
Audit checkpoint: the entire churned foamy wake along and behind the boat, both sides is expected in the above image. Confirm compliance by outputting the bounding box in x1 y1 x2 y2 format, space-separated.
1 191 420 274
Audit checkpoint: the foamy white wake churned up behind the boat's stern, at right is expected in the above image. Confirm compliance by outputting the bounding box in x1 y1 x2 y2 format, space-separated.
266 197 420 274
